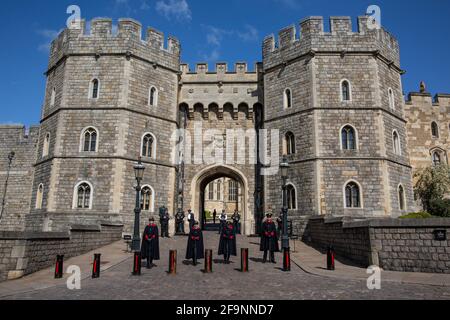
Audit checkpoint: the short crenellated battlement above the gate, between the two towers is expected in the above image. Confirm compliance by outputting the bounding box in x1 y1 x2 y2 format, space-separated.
180 62 262 75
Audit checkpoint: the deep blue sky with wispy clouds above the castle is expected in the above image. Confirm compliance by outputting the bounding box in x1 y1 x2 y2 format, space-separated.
0 0 450 125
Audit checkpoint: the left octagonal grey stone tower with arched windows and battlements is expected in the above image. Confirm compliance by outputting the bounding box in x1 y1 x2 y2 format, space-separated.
29 18 181 231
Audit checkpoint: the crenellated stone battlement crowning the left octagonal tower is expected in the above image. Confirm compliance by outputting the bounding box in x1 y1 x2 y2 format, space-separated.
49 18 181 70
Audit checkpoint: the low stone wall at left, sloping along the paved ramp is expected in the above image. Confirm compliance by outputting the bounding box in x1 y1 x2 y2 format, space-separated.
0 224 123 281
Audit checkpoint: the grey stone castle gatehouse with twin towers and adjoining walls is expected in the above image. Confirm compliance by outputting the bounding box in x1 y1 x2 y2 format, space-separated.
0 17 450 238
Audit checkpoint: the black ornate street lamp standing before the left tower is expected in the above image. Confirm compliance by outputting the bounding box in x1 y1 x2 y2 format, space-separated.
131 158 145 275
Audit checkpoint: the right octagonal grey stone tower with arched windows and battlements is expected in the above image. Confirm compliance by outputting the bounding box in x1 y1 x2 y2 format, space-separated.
263 17 413 220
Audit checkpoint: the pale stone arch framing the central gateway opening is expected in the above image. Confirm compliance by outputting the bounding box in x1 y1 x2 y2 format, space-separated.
191 165 255 235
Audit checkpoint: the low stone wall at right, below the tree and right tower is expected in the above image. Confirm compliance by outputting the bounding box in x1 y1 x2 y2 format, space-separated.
304 217 450 273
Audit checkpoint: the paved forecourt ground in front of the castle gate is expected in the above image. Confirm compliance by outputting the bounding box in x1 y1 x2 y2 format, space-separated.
0 232 450 300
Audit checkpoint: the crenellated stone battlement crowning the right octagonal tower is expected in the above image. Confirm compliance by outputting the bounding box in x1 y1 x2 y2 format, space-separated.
263 16 400 69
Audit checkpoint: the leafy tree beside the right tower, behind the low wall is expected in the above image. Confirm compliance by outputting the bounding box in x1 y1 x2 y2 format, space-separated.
414 165 450 215
